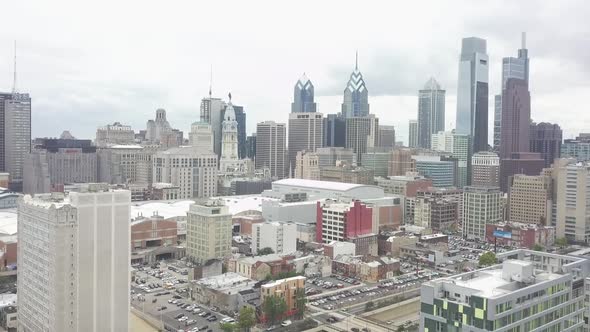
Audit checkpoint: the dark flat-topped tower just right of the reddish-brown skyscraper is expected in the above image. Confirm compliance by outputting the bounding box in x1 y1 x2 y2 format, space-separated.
530 122 563 167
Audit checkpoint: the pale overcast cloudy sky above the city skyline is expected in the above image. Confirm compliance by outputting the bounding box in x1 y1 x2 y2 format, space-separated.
0 0 590 142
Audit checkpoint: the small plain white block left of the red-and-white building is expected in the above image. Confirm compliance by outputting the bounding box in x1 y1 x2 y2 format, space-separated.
252 221 297 255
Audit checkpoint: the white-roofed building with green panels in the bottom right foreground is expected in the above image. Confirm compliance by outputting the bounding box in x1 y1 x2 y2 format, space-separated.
420 249 590 332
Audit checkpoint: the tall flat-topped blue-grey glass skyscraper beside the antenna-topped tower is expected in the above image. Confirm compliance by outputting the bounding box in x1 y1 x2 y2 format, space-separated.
456 37 489 152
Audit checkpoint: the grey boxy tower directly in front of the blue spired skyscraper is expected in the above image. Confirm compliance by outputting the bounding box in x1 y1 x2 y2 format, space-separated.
346 114 379 165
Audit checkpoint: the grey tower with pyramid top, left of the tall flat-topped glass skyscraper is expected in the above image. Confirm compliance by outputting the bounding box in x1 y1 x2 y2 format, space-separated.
418 77 445 149
